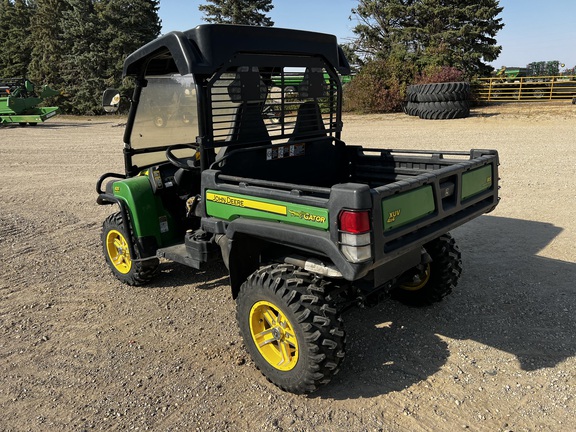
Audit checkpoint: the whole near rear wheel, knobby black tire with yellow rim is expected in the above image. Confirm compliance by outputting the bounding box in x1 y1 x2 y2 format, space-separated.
236 264 345 394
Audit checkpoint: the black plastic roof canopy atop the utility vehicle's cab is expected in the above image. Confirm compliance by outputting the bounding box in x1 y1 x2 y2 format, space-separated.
124 24 350 76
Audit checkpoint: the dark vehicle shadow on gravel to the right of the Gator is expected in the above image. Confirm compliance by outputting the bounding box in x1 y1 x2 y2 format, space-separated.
313 216 576 399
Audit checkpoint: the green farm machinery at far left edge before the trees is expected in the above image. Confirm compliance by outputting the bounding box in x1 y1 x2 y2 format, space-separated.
0 78 60 126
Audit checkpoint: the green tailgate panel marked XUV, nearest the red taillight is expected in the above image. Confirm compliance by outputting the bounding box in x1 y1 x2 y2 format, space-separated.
382 185 436 231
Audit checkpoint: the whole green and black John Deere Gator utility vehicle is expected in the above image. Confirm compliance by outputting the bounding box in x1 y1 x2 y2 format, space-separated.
96 24 498 393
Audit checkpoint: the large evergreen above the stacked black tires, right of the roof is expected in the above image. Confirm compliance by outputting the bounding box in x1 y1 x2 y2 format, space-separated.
352 0 504 76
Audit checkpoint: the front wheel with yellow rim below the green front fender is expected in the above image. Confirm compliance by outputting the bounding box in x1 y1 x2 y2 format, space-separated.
101 212 159 286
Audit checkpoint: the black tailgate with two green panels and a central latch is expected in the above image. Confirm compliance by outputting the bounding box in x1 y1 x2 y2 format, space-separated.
372 150 498 261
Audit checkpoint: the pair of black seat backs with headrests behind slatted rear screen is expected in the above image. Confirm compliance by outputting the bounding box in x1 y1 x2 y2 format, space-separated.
216 69 348 187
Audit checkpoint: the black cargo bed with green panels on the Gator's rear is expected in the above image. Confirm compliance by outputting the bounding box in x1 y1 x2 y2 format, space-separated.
202 143 498 280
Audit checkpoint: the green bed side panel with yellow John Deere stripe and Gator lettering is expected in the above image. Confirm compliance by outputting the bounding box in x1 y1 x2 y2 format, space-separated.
205 190 329 230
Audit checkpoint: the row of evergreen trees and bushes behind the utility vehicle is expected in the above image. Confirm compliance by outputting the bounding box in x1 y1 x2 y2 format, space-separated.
0 0 503 114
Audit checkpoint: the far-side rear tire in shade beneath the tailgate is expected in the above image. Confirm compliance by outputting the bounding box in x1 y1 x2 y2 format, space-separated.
392 233 462 306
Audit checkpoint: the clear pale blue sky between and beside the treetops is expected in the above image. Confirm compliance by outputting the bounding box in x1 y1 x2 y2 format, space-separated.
159 0 576 68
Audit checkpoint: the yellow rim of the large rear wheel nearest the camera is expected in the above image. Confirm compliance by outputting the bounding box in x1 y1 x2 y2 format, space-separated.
250 301 299 371
